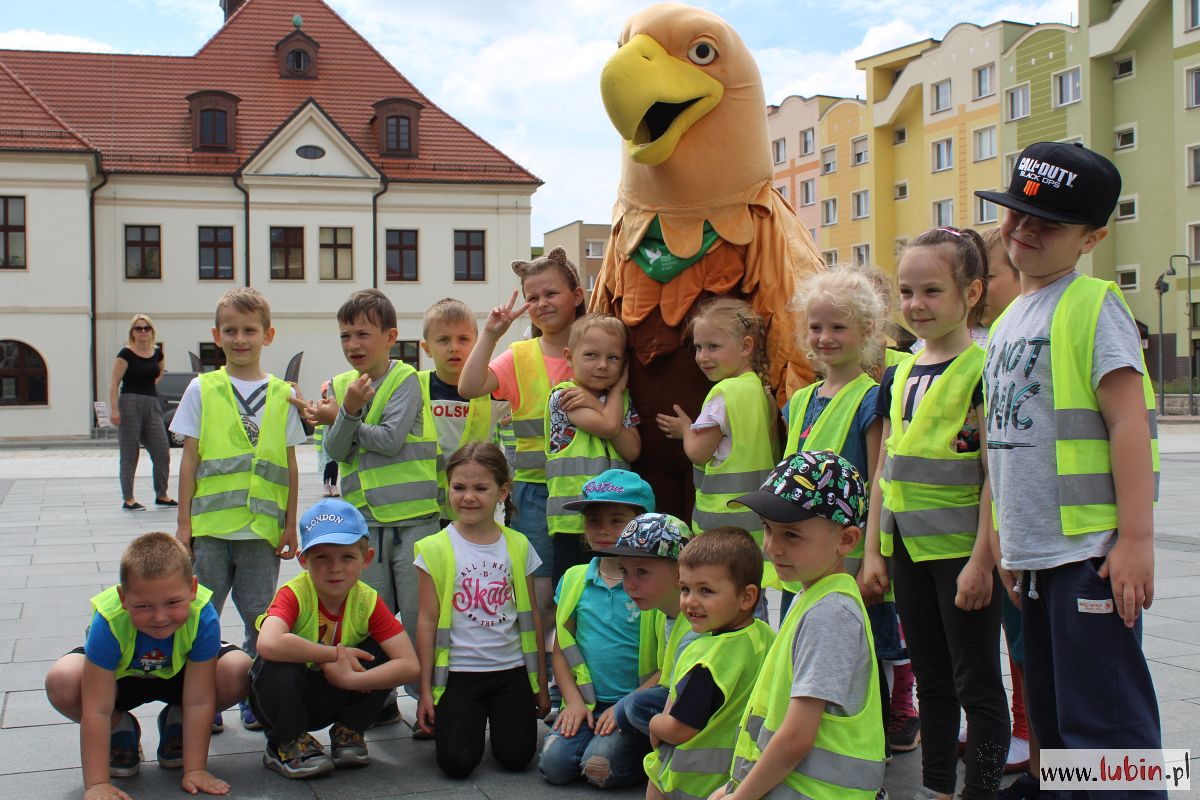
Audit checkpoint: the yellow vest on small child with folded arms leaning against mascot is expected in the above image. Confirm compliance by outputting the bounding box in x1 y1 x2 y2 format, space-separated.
545 380 629 536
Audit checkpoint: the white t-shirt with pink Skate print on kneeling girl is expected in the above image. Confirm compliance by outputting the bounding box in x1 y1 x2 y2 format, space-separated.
413 525 541 672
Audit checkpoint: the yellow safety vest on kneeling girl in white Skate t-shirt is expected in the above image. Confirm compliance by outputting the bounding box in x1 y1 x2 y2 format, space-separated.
414 527 541 705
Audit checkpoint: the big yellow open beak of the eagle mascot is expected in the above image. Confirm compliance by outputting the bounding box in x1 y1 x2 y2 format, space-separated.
600 34 725 167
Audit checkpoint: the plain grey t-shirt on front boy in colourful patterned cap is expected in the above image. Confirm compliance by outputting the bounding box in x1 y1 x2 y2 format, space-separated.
791 593 871 717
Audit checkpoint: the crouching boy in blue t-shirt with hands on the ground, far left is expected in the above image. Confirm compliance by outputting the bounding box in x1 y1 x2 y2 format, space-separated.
46 533 250 800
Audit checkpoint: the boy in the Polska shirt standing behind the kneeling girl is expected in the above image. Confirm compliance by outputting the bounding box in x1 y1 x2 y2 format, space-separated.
419 297 510 528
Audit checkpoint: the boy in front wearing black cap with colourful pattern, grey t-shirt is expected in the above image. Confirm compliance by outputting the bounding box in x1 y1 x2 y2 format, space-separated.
712 450 887 800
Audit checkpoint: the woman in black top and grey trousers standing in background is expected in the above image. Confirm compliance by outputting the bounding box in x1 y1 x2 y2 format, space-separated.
108 314 179 511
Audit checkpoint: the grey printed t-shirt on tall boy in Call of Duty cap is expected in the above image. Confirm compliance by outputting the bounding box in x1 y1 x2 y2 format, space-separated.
983 272 1142 570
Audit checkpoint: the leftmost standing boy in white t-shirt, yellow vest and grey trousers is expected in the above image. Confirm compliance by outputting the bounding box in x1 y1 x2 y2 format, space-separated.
170 288 308 730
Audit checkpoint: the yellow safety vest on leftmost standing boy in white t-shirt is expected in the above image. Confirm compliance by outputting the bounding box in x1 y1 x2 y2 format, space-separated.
191 367 292 547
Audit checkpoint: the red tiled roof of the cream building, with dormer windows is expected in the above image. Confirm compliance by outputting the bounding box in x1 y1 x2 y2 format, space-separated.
0 0 541 185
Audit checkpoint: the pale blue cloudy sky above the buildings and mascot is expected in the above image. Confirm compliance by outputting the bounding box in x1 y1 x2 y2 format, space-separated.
0 0 1076 246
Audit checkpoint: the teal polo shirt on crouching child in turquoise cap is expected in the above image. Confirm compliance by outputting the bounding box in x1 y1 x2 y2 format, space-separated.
554 558 640 703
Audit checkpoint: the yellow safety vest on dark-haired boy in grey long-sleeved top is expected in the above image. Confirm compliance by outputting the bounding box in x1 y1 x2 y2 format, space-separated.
334 361 439 523
